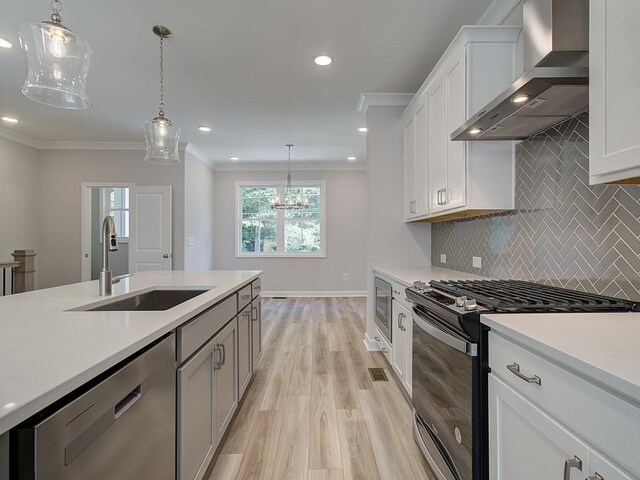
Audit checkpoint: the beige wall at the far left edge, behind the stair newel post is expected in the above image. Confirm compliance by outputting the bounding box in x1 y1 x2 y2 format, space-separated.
0 137 40 285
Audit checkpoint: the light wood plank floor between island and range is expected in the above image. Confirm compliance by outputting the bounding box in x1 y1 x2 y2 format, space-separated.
209 298 432 480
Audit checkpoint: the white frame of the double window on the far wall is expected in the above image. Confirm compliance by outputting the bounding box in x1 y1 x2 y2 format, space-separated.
234 180 327 258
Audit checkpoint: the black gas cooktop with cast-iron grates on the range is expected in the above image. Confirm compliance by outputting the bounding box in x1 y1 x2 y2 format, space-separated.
429 280 640 313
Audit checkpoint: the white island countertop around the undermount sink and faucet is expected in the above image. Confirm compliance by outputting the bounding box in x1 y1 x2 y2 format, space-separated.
0 270 261 435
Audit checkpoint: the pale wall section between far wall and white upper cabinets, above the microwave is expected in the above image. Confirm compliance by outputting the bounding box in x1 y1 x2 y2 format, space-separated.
366 106 431 339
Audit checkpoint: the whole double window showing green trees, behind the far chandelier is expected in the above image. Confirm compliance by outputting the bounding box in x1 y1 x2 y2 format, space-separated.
236 182 325 257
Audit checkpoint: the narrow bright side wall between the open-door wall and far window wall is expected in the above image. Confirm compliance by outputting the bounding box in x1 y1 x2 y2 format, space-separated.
184 147 215 270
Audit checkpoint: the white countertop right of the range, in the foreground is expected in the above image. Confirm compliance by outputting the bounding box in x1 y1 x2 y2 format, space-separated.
482 313 640 403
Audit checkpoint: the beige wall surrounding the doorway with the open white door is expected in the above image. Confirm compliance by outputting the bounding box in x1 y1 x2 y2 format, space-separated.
36 150 184 288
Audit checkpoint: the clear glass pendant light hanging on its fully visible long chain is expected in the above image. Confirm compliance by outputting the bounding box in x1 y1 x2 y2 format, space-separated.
144 25 180 165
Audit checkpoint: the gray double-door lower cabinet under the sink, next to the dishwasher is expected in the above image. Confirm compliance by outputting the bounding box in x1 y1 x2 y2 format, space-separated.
177 318 238 480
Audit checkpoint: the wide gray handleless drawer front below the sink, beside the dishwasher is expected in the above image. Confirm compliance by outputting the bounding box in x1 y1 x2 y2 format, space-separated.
178 294 238 363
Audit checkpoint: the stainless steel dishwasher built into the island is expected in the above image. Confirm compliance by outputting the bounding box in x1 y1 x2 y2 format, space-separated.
11 334 176 480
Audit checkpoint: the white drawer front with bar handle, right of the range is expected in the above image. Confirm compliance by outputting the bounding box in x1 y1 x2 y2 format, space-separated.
489 331 640 475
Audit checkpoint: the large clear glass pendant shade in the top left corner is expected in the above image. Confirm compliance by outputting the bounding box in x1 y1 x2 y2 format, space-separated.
18 0 91 109
